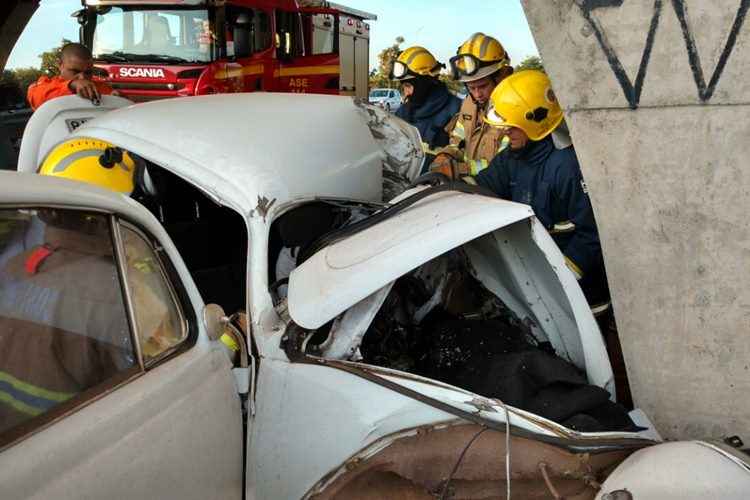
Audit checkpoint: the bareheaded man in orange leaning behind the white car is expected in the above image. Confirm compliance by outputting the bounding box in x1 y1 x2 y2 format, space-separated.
26 43 117 110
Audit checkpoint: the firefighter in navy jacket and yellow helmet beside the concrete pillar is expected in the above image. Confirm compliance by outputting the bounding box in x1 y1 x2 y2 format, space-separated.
474 70 609 314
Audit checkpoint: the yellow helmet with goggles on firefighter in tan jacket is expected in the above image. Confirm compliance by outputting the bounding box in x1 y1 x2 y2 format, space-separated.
450 33 510 83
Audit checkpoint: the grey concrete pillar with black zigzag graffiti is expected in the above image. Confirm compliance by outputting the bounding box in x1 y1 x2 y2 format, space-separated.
522 0 750 443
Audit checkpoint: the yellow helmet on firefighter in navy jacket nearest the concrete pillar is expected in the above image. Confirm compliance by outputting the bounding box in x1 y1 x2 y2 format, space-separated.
484 70 563 141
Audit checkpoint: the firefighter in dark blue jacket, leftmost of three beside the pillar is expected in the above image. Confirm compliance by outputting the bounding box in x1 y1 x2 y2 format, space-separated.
391 46 461 171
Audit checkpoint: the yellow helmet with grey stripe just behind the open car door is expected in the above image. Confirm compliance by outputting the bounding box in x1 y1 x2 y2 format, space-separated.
39 137 136 195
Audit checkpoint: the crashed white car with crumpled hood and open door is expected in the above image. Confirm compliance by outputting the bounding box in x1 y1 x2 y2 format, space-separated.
0 94 750 500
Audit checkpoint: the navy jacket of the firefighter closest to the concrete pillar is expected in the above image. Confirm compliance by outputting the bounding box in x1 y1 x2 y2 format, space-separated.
475 136 609 311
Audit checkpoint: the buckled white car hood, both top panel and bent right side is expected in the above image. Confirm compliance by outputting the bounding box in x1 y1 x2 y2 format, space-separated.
289 190 613 393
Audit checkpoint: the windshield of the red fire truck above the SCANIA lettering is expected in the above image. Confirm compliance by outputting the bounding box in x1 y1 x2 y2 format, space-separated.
92 6 216 64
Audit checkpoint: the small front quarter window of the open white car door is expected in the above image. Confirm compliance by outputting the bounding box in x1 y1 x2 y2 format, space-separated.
121 225 187 366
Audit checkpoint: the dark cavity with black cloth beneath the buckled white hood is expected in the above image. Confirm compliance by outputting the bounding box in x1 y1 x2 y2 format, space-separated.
360 252 638 432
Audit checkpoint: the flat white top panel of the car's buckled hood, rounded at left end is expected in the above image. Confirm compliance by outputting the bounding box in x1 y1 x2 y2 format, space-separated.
289 193 533 328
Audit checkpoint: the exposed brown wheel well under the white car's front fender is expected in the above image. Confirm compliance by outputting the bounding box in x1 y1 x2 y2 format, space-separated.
304 422 630 499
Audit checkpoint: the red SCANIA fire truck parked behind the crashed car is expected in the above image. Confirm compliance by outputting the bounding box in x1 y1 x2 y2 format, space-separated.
74 0 376 101
